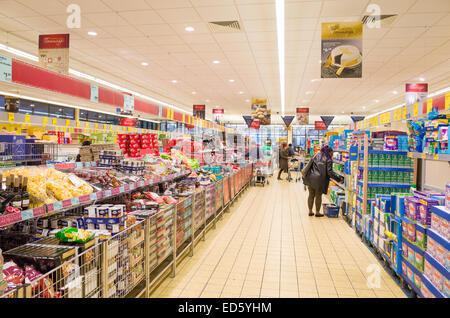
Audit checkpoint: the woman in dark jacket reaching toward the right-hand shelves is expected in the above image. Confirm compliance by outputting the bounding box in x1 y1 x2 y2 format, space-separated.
303 145 343 217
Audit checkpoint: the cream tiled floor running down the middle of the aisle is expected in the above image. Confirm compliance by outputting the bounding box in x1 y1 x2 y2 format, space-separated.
152 178 406 298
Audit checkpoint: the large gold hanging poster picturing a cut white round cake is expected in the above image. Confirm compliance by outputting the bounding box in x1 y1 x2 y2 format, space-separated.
321 22 363 78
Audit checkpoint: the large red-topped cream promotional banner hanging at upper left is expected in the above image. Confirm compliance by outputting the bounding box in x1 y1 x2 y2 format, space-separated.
39 34 70 75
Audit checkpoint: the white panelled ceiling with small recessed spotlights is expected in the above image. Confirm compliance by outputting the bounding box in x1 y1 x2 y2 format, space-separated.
0 0 450 121
